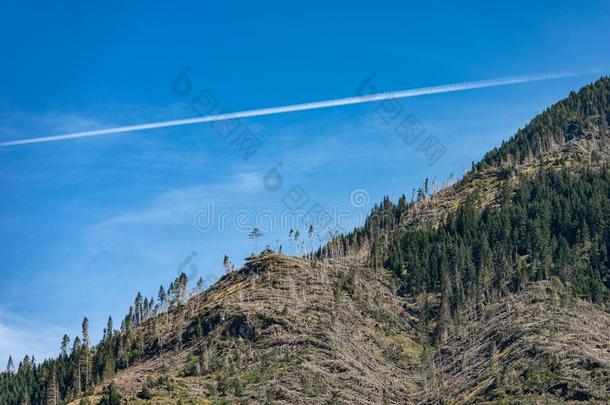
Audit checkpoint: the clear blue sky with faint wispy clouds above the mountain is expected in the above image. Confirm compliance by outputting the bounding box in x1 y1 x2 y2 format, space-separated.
0 1 610 367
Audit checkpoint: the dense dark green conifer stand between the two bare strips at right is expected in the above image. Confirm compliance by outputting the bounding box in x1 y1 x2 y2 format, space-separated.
385 163 610 313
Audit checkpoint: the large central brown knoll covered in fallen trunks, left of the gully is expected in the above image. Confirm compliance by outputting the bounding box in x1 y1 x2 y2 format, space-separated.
88 254 421 404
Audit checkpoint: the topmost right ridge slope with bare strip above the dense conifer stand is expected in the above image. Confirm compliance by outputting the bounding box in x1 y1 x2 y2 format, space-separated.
403 77 610 232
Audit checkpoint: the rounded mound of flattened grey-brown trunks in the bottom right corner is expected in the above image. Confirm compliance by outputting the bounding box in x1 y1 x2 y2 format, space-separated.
427 280 610 403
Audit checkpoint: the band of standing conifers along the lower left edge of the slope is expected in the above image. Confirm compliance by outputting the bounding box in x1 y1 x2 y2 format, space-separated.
0 273 197 404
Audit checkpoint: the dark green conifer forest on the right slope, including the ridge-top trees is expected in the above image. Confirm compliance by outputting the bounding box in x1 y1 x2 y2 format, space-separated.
318 77 610 318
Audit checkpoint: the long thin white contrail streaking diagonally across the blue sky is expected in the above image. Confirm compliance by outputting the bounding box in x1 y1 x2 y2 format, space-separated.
0 73 582 147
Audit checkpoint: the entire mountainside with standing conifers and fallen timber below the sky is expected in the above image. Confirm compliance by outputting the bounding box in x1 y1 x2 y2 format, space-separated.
0 78 610 405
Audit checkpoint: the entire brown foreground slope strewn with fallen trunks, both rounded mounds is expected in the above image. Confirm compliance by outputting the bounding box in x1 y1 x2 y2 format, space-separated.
77 254 610 404
